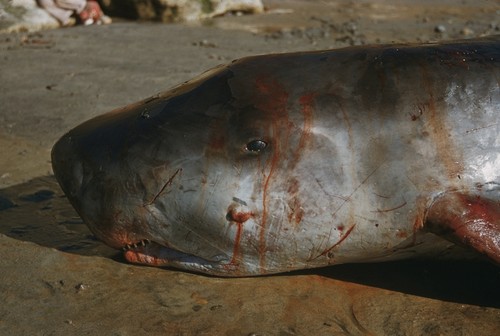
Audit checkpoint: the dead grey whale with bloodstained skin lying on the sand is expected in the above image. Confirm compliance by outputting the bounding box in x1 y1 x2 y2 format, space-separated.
52 37 500 276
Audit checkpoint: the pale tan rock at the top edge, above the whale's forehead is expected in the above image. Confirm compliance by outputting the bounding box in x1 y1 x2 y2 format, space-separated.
101 0 264 22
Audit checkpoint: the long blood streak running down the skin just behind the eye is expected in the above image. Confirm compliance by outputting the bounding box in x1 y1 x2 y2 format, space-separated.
255 76 290 270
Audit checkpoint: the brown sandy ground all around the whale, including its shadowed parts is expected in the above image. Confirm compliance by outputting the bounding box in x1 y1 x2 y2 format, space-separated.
0 1 500 335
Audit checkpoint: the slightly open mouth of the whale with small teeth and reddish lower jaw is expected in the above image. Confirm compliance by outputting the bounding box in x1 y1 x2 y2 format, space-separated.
122 239 223 269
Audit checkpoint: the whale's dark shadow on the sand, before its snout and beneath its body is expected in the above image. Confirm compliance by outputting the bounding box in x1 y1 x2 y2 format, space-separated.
0 176 500 308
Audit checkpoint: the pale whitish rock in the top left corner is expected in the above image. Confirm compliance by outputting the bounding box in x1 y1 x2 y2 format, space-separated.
0 0 59 33
